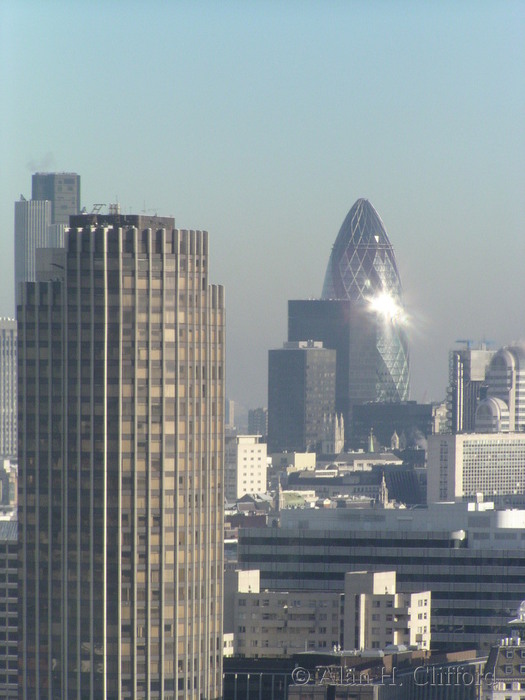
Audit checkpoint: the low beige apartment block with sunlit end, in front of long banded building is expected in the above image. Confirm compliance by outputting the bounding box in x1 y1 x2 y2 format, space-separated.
232 571 431 658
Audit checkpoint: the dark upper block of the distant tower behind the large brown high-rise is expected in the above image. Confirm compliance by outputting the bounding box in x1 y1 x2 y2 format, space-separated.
31 173 80 226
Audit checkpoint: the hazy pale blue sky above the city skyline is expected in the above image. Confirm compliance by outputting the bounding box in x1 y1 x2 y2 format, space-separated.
0 0 525 408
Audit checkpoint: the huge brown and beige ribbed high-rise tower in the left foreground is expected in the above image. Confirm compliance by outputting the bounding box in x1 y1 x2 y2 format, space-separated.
18 215 224 700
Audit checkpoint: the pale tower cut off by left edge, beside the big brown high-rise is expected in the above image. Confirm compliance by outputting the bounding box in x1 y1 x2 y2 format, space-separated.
0 318 18 459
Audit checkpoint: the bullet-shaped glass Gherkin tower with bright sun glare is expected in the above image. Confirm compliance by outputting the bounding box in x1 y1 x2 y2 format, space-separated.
322 199 409 404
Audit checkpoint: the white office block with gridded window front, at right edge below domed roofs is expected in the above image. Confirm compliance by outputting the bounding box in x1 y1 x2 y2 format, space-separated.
427 433 525 504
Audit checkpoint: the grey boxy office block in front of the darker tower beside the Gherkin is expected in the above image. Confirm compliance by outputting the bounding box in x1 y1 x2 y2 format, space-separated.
268 341 335 452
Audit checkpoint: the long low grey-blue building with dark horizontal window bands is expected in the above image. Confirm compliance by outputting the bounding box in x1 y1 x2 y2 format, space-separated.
238 503 525 653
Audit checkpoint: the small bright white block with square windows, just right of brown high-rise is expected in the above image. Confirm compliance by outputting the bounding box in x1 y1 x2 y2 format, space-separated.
224 435 268 503
